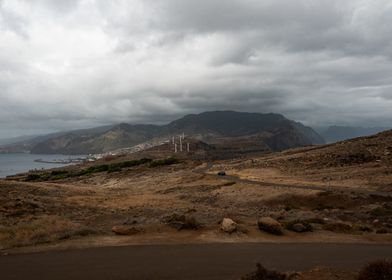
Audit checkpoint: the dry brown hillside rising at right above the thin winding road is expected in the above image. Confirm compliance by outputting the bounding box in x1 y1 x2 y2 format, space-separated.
224 131 392 191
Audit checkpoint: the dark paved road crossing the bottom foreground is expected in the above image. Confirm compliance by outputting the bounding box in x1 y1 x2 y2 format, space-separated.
0 243 392 280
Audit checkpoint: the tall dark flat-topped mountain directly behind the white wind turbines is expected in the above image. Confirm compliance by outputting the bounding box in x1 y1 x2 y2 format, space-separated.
166 111 324 151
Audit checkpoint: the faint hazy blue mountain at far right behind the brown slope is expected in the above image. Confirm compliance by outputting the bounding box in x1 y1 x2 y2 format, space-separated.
316 126 390 143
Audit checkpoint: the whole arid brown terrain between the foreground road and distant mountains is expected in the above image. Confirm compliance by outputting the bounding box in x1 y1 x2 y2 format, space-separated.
0 131 392 279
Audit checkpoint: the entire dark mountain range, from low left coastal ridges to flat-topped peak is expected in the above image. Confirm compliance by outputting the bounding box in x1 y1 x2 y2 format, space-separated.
6 111 324 154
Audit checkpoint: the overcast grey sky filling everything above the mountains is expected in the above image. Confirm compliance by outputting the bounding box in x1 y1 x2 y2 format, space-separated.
0 0 392 138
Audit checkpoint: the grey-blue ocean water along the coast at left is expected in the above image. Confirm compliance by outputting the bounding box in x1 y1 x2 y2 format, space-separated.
0 154 80 178
